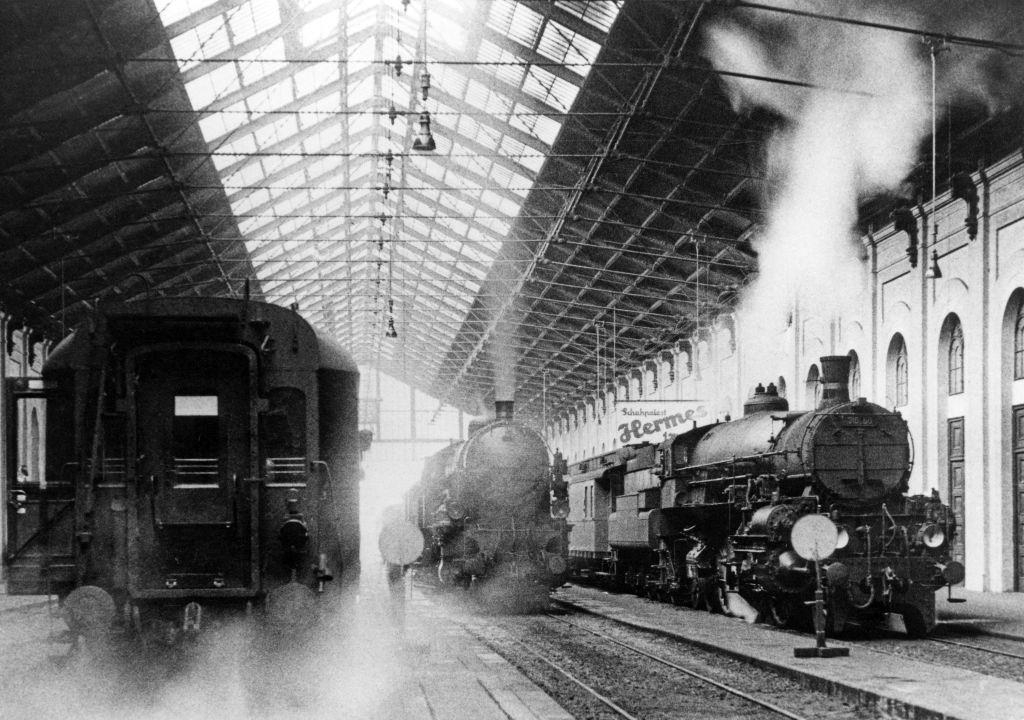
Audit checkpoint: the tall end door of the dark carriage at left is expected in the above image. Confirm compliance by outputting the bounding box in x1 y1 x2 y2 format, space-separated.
129 345 256 598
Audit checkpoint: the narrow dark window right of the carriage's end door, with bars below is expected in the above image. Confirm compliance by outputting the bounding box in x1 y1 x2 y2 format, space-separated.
260 387 306 482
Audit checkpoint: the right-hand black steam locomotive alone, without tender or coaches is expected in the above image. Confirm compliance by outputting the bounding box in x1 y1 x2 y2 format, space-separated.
658 356 964 635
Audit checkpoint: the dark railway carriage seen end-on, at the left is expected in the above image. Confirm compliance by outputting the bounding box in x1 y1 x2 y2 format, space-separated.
6 298 360 637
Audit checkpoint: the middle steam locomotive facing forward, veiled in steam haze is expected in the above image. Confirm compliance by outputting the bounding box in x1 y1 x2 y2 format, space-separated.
406 401 568 609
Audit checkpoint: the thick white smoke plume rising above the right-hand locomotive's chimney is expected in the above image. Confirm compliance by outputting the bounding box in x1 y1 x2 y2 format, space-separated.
706 0 1020 343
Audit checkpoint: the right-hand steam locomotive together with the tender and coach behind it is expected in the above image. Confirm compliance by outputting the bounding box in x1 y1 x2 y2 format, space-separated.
568 356 964 636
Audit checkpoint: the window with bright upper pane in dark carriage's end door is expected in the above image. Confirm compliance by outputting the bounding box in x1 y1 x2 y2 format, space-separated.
172 395 220 485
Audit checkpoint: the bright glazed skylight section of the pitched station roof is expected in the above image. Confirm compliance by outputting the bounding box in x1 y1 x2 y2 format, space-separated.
157 0 621 378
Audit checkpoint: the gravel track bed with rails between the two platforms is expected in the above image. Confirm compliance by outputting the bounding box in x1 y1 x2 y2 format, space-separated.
456 613 886 720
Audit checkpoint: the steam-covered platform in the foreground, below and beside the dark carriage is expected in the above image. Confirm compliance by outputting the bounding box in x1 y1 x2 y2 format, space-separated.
0 582 573 720
